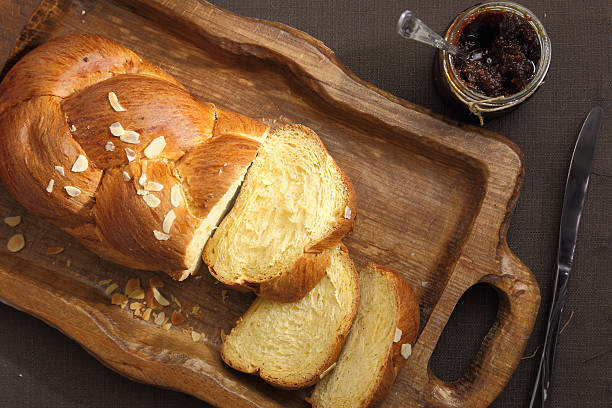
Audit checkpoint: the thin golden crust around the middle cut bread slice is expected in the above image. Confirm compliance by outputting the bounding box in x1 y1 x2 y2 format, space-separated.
221 243 360 390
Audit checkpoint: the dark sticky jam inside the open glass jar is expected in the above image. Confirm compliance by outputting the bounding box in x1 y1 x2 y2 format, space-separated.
452 11 541 97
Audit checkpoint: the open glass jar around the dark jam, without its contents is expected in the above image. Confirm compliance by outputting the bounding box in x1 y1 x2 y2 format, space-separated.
434 1 551 124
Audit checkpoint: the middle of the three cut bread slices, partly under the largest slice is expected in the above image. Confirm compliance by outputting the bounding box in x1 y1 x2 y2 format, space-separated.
221 245 359 389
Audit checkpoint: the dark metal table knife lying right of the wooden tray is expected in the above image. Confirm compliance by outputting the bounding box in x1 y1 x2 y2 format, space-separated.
529 106 603 408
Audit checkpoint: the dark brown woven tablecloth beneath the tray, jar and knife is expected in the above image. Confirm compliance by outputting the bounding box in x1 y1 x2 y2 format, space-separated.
0 0 612 408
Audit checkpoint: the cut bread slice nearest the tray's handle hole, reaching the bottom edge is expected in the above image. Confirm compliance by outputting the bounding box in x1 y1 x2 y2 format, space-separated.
311 264 419 408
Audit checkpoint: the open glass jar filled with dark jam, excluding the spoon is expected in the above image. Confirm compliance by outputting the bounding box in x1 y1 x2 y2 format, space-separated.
434 1 551 124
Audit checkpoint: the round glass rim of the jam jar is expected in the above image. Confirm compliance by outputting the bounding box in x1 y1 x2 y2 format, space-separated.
440 1 551 112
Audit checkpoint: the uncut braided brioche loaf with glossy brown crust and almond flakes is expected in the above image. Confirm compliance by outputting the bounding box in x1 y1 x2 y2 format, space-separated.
0 35 268 280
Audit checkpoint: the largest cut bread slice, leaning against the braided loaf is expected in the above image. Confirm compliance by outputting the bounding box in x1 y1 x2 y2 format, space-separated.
203 125 356 302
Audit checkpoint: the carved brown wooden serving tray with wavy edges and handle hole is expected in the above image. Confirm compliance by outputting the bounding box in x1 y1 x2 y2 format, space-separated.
0 0 539 408
